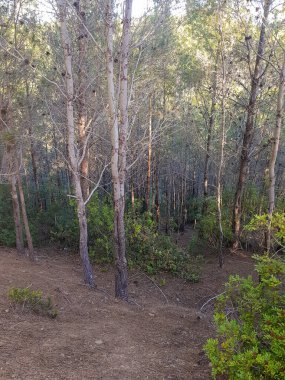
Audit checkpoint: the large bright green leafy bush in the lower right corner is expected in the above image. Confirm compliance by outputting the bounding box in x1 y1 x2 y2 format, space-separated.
205 256 285 380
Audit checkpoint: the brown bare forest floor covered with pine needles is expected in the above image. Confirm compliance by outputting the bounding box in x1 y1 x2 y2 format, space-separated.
0 229 253 380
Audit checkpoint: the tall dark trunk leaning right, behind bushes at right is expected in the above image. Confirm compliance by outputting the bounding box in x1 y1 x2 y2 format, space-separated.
232 0 272 248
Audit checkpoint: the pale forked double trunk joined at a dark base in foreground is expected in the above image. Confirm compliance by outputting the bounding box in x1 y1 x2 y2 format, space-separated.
106 0 132 301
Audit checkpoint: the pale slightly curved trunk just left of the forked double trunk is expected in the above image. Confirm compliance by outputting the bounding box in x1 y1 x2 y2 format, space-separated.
58 0 95 287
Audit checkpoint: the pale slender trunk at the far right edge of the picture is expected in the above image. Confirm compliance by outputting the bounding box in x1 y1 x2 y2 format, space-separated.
266 53 285 252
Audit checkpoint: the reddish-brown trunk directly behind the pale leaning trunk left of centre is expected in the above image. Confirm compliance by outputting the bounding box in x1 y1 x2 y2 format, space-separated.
74 0 90 200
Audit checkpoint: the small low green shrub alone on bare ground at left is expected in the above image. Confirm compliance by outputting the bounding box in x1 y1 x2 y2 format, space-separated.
8 288 58 318
